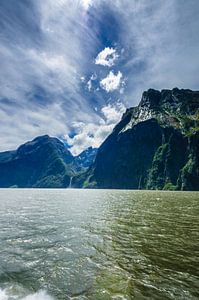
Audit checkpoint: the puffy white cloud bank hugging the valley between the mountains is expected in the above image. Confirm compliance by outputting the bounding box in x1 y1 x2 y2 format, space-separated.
65 102 126 155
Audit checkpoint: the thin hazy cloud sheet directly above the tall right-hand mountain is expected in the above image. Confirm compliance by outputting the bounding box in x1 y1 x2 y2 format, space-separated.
110 0 199 105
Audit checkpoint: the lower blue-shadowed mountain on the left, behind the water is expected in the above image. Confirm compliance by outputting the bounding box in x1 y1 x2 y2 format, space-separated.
0 135 97 188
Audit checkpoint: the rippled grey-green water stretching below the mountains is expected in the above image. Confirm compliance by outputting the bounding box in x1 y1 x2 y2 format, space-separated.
0 189 199 300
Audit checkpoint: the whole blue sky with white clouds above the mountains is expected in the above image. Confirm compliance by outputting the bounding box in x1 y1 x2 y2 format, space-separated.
0 0 199 155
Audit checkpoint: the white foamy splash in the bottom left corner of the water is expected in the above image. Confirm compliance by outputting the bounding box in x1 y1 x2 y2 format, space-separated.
0 289 53 300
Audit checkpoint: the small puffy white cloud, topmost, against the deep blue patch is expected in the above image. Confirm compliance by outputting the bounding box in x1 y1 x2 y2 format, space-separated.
95 47 119 67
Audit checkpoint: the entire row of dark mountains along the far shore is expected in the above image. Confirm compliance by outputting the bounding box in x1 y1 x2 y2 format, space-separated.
0 88 199 190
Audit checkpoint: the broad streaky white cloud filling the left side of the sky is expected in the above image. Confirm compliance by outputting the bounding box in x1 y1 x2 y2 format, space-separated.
0 0 100 150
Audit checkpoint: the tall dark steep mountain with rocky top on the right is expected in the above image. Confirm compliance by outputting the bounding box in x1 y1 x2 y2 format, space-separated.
73 88 199 190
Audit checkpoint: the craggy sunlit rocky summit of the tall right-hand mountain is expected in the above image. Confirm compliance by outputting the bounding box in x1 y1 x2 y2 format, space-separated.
119 88 199 131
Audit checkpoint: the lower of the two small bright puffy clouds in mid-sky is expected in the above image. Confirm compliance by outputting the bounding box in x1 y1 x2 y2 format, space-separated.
100 71 123 93
